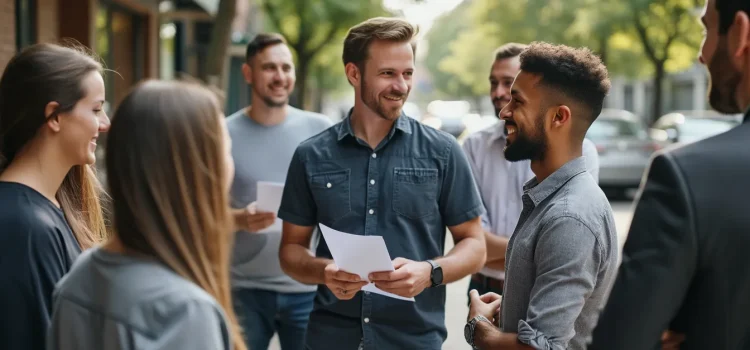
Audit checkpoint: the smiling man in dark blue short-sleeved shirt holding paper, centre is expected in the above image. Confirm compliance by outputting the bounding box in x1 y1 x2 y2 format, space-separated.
278 18 485 350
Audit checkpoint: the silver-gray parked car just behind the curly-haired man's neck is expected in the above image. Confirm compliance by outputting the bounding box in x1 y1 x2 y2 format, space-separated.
586 109 660 197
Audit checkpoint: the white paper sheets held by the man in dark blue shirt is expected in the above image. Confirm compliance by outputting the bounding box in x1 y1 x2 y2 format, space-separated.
319 224 414 301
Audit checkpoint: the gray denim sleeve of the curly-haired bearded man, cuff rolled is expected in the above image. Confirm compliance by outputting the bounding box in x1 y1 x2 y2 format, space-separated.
518 216 602 350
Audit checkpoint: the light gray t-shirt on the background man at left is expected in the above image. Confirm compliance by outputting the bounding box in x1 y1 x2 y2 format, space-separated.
227 106 333 293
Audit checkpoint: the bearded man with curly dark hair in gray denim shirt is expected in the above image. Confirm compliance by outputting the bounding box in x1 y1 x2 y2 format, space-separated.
465 43 618 350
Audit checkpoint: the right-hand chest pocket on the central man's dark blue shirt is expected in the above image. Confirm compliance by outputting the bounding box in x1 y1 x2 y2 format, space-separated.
393 168 438 219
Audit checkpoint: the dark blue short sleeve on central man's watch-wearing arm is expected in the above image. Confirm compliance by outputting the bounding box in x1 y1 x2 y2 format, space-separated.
438 140 485 226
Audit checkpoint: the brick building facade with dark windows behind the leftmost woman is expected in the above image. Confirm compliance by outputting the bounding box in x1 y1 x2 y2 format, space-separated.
0 0 159 109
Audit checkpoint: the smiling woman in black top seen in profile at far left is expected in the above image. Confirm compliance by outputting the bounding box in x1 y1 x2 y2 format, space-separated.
0 44 109 350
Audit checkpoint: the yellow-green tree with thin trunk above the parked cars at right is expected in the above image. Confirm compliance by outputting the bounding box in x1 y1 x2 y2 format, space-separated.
626 0 701 121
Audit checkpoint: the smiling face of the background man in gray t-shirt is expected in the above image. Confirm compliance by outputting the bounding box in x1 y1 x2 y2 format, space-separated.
243 44 296 107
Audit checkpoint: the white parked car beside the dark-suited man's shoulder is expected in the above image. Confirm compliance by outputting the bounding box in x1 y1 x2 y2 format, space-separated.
649 111 742 145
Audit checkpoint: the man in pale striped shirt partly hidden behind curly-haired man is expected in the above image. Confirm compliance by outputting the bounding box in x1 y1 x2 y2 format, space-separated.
462 43 599 302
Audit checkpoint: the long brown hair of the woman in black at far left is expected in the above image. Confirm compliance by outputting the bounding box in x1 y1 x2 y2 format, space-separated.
0 43 107 249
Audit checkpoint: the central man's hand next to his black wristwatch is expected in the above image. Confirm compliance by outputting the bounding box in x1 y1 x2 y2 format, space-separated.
370 258 432 298
